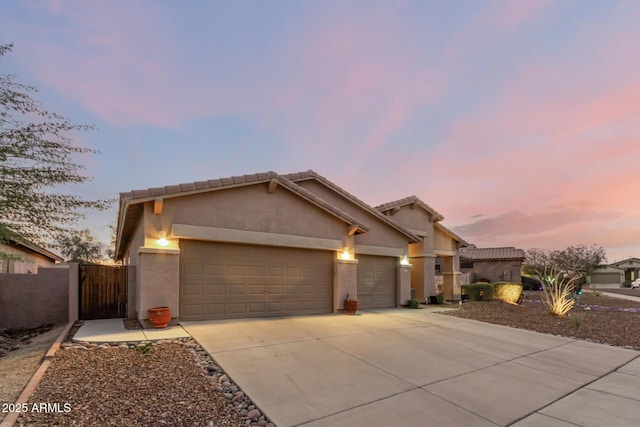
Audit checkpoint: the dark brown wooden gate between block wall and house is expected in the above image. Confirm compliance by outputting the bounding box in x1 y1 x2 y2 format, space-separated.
78 264 127 320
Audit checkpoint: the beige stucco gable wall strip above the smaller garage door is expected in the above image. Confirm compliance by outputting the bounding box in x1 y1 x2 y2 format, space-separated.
296 180 409 250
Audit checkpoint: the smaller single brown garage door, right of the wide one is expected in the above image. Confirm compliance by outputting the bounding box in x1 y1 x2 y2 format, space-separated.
357 255 398 308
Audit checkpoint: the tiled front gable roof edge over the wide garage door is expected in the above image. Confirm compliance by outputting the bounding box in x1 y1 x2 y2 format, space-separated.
116 171 369 259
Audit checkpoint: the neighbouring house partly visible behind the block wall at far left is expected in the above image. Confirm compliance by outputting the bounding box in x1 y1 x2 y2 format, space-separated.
0 241 63 274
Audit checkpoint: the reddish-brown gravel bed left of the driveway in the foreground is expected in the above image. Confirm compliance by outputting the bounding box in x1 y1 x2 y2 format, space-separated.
16 339 270 426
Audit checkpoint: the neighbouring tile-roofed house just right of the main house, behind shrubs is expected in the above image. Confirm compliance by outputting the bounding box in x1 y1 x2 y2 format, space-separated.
460 245 525 283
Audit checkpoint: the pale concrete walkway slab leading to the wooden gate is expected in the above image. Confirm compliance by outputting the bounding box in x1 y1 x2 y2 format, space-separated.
73 319 190 343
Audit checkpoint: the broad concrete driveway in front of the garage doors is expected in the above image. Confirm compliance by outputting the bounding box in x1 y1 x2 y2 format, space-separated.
182 309 640 427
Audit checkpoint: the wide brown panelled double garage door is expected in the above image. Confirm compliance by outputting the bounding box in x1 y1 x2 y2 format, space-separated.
180 240 333 320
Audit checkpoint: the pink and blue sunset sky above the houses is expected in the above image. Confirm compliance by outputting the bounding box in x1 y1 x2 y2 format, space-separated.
0 0 640 262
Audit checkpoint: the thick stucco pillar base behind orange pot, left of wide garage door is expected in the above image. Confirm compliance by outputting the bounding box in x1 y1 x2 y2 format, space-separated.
136 247 180 321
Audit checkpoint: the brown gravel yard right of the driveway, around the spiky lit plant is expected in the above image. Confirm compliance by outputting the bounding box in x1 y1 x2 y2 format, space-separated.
442 291 640 350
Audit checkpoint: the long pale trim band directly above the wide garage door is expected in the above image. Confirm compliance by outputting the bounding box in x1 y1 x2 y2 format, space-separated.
171 224 343 251
